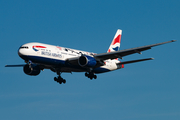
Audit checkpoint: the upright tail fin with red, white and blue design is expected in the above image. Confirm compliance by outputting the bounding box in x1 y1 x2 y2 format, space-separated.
107 29 122 52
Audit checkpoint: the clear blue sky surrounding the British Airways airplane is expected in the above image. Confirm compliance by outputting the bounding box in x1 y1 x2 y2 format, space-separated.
0 0 180 120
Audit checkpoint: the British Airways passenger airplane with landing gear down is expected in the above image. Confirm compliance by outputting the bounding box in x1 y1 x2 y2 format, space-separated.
5 29 176 84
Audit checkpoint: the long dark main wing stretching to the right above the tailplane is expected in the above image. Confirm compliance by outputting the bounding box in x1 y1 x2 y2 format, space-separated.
94 40 176 60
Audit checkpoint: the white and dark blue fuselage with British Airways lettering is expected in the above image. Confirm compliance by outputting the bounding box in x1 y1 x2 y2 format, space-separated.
18 42 120 73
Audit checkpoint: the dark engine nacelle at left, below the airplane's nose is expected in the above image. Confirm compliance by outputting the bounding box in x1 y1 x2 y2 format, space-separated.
23 64 41 76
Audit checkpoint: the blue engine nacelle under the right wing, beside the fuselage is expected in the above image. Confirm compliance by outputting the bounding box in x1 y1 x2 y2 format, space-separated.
78 55 97 67
